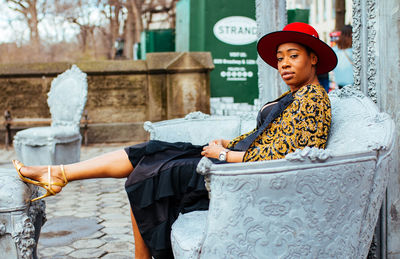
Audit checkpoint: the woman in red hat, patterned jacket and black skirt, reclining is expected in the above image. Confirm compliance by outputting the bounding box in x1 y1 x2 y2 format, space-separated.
13 23 337 258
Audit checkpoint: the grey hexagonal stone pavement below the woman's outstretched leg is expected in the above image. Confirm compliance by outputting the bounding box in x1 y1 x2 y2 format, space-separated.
0 143 141 259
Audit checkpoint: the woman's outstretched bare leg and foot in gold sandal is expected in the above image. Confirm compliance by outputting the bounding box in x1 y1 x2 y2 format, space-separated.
17 150 133 192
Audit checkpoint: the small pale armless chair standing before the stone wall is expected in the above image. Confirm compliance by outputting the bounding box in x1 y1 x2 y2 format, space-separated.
14 65 87 165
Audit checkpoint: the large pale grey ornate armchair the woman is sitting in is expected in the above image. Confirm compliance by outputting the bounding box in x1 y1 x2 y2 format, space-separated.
146 88 395 258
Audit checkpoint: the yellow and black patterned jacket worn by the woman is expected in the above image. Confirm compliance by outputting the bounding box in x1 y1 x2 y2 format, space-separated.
228 85 332 162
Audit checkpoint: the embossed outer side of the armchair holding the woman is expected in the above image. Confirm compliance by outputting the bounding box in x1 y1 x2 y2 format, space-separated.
198 151 386 258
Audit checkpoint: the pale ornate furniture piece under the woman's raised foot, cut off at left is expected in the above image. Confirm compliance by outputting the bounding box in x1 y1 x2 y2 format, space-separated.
0 168 46 259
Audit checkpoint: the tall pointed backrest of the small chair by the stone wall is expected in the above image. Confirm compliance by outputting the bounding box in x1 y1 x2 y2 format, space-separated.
47 65 87 129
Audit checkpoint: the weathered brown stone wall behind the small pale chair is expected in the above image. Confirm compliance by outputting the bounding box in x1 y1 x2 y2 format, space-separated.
0 52 213 143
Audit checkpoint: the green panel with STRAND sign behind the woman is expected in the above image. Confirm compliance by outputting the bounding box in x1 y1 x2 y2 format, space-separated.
176 0 258 104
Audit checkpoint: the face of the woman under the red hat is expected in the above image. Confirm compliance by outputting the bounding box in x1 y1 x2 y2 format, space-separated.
276 43 318 92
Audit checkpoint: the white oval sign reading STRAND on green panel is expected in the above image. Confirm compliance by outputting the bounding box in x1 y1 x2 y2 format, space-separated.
213 16 257 45
